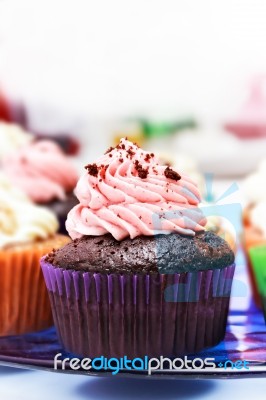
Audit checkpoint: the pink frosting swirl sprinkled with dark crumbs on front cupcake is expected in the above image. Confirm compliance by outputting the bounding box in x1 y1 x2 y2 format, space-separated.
66 139 206 240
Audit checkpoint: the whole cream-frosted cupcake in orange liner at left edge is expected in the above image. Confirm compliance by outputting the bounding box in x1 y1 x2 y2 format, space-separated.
0 174 69 336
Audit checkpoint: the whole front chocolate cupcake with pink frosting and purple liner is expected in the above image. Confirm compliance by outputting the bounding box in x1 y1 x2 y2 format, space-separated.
41 139 235 357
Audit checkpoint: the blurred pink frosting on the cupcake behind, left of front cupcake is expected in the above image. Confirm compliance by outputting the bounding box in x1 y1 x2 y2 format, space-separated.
3 140 78 203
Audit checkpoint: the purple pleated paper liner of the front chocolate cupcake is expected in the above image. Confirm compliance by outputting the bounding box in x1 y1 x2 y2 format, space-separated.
41 259 235 358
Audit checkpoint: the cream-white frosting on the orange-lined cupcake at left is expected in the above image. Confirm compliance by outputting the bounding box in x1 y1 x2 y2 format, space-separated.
0 174 58 249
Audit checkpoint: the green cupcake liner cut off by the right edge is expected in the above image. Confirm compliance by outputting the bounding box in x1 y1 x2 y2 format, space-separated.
249 245 266 296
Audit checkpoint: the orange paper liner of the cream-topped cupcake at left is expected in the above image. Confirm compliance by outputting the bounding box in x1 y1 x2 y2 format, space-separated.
0 235 69 336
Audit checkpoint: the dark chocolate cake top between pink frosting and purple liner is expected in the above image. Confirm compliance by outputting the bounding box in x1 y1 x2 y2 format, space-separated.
46 231 234 274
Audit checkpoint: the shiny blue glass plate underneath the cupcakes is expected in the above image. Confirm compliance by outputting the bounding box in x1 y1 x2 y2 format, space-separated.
0 253 266 379
